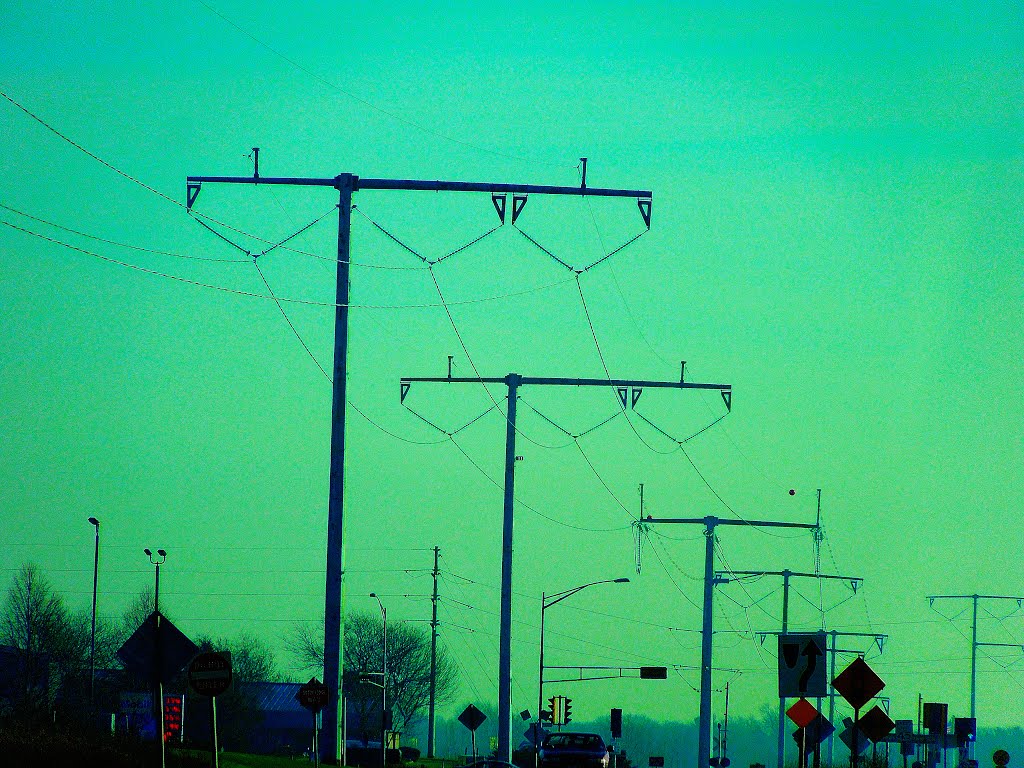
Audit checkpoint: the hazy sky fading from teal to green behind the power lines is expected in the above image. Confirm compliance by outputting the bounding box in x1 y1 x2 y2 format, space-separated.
0 0 1024 749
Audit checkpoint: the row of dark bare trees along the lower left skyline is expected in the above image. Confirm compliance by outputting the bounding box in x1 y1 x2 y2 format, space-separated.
0 563 458 742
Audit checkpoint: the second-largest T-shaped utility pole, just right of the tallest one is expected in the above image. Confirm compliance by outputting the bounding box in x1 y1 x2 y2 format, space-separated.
401 374 732 766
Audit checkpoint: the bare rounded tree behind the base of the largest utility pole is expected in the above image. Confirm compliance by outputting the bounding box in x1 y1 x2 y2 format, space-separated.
286 611 458 731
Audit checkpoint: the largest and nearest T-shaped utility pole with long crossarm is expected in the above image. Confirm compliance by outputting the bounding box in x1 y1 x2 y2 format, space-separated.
185 162 652 764
